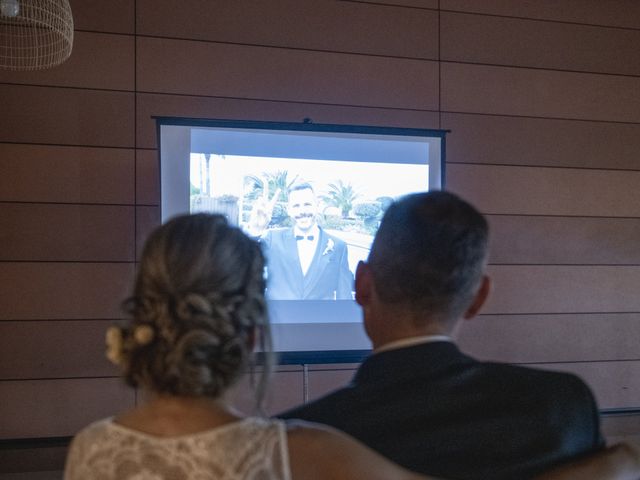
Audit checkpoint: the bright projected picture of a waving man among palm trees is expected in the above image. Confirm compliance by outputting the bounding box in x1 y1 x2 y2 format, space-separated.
190 153 429 300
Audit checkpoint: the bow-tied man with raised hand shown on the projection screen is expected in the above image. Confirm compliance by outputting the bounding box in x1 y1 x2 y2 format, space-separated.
247 183 353 300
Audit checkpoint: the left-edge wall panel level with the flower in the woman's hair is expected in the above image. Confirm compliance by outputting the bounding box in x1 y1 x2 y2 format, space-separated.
0 320 118 380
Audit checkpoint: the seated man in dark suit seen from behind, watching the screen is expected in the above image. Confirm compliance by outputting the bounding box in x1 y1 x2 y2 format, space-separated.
281 191 603 480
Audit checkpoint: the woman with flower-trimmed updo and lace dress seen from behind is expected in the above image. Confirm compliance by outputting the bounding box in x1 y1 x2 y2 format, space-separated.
65 214 637 480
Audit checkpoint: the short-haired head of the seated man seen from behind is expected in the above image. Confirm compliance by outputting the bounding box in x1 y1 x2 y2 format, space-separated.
356 191 489 346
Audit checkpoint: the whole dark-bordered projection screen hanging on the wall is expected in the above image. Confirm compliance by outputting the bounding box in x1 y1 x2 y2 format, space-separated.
156 117 446 363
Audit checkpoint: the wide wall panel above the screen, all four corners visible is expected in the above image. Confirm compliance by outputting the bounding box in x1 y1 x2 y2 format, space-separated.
137 38 438 110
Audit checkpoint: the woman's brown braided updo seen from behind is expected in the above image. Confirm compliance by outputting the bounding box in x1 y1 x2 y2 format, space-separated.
116 214 270 397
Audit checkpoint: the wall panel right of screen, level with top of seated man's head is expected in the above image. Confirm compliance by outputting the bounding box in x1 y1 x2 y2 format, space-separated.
447 164 640 217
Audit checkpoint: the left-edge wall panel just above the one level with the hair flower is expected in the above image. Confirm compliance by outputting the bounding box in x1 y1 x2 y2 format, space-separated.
0 262 133 320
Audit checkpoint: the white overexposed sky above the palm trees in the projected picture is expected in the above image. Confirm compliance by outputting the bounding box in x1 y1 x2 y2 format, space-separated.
190 153 429 201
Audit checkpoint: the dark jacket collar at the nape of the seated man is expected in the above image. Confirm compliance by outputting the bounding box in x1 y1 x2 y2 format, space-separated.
353 341 475 384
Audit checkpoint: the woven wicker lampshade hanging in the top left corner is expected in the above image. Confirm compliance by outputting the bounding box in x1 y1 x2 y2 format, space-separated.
0 0 73 70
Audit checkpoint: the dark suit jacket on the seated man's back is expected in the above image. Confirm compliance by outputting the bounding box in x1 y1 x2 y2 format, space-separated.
280 342 603 480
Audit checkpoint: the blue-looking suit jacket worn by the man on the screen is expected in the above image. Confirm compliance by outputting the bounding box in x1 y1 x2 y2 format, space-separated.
260 228 353 300
